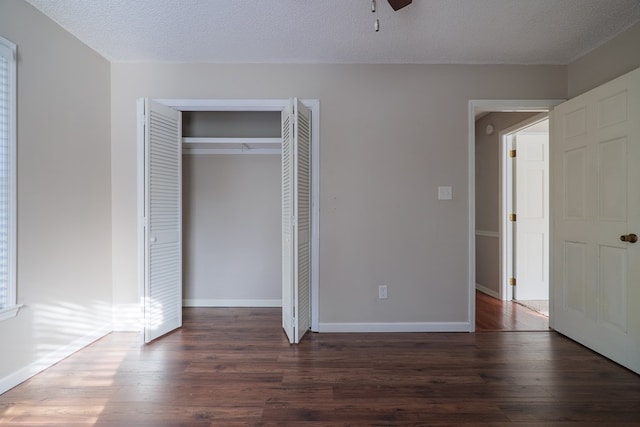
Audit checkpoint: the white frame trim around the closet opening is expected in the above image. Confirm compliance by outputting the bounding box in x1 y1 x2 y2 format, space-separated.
137 98 320 332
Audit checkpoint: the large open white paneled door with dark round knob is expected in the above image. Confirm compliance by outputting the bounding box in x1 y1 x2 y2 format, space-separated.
551 69 640 373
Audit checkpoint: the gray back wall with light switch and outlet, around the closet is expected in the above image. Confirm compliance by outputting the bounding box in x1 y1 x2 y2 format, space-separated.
112 64 566 328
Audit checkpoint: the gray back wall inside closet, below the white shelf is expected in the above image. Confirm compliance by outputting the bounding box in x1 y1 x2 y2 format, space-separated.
183 154 282 306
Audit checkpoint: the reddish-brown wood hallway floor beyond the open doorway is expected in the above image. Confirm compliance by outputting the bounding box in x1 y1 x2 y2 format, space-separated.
476 292 549 332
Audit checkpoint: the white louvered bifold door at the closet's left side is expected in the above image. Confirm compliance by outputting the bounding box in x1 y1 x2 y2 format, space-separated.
144 100 182 342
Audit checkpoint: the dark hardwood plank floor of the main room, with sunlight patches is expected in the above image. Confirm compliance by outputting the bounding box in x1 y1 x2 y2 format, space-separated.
0 308 640 427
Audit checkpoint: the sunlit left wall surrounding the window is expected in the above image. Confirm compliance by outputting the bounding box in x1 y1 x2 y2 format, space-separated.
0 0 112 392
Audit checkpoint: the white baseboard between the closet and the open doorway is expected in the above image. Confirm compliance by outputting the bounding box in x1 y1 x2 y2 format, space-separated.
319 322 471 332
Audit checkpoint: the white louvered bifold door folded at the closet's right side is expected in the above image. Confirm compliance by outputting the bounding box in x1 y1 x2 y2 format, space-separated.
282 99 311 344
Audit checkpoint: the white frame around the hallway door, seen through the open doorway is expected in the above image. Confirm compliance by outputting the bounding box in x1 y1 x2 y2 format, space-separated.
498 113 551 301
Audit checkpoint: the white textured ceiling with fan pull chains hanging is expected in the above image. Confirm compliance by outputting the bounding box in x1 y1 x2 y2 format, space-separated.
22 0 640 64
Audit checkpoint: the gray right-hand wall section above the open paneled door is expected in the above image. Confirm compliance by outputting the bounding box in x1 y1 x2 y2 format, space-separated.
567 23 640 98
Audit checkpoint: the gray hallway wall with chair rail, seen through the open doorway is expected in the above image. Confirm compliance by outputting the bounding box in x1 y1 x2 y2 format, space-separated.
475 113 538 296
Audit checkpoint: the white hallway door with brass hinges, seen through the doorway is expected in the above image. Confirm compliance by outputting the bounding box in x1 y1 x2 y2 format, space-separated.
513 133 549 301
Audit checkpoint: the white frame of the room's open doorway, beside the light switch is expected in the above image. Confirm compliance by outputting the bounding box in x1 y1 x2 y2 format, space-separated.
467 99 565 332
